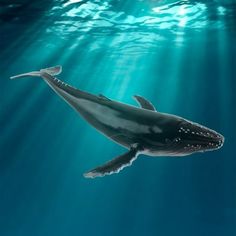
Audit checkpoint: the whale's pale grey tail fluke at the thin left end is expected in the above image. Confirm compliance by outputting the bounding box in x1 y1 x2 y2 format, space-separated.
10 65 62 79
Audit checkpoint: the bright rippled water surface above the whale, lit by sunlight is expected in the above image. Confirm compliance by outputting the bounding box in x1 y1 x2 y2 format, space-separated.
0 0 236 53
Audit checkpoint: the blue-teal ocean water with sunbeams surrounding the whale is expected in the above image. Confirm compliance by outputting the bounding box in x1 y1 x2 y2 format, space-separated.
0 0 236 236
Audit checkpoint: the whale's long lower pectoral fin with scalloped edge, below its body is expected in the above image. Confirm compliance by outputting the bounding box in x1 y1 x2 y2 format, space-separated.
84 148 138 178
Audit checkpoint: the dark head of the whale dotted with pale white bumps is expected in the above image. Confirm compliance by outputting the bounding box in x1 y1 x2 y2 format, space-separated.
167 120 224 156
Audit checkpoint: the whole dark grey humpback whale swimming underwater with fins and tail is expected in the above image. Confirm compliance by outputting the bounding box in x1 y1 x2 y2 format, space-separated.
11 66 224 178
